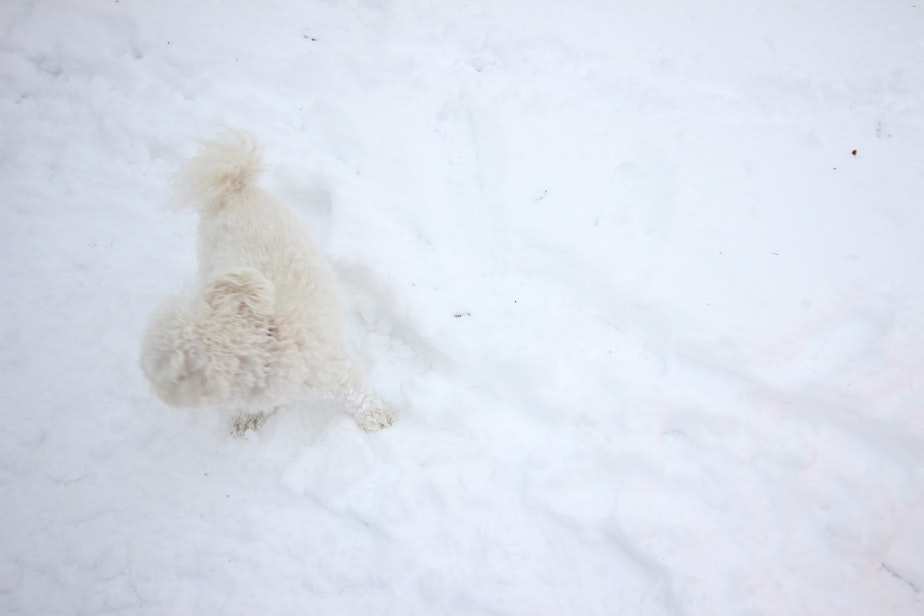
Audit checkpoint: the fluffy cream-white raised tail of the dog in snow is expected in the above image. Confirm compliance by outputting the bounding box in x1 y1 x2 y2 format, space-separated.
175 131 264 210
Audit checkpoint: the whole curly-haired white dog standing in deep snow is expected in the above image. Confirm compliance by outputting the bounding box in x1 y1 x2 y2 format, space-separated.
141 132 394 432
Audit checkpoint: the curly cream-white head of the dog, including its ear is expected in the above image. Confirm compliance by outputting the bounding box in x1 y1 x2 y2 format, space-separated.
141 268 275 406
